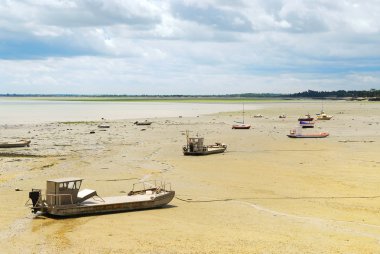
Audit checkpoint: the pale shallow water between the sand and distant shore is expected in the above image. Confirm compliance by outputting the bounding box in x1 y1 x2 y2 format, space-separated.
0 98 260 125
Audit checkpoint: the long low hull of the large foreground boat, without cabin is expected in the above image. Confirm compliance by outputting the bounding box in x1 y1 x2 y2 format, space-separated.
45 191 175 217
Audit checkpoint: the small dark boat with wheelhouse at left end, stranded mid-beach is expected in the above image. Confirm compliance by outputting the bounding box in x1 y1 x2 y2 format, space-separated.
182 131 227 155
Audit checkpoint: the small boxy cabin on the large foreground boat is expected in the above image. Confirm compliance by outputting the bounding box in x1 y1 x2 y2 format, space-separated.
46 177 97 206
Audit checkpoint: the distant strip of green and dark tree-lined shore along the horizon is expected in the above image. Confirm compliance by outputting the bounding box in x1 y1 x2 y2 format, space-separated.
0 89 380 103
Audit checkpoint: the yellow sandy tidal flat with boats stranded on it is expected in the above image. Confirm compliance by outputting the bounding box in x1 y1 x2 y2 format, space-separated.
0 101 380 254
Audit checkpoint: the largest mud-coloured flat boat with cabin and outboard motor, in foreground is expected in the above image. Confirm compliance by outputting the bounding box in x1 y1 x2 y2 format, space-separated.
28 178 175 217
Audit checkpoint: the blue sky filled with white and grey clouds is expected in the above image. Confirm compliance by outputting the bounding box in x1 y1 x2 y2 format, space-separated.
0 0 380 94
